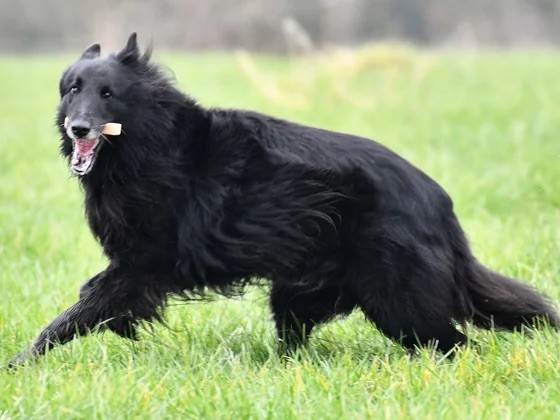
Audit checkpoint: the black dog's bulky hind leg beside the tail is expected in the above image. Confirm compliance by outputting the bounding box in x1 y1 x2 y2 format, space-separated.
353 238 467 353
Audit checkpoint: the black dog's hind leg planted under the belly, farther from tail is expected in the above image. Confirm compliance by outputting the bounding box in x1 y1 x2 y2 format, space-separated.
270 284 355 353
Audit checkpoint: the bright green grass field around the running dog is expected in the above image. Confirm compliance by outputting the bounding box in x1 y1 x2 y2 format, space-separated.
0 47 560 419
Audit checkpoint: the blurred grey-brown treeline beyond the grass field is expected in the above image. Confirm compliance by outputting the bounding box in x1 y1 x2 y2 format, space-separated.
0 0 560 54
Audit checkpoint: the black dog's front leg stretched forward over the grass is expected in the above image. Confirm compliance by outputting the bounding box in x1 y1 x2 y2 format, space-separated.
9 268 166 367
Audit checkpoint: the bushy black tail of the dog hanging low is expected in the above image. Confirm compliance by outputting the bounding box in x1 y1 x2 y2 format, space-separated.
466 264 560 330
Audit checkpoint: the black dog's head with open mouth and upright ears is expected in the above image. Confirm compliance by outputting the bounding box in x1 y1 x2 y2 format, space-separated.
57 33 164 176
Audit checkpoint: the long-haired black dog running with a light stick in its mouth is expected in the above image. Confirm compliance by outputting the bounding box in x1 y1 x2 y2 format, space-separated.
7 34 560 364
